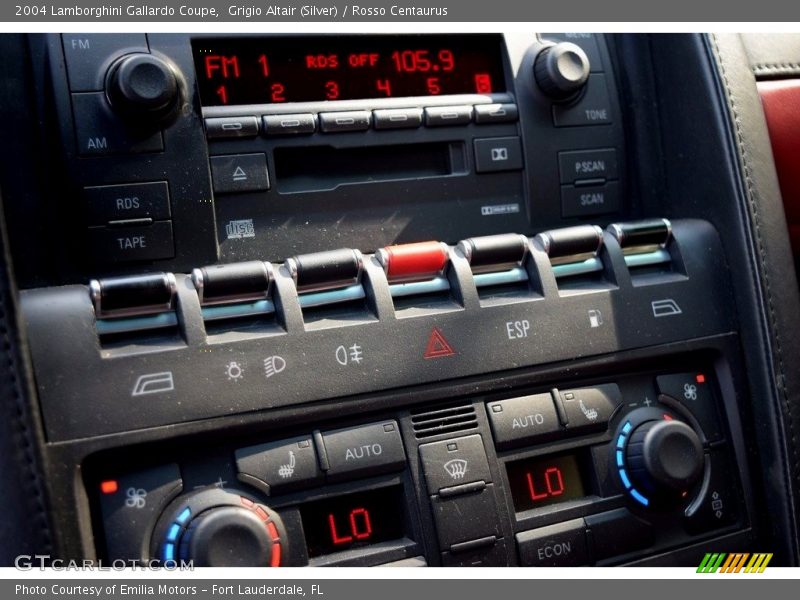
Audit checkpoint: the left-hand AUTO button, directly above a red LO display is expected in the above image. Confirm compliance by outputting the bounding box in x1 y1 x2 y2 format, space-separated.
320 421 406 481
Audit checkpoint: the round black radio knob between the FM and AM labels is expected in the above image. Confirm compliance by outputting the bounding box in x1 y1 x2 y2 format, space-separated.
106 52 180 123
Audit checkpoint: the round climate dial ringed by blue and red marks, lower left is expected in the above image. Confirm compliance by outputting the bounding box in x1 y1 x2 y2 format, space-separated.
153 488 286 567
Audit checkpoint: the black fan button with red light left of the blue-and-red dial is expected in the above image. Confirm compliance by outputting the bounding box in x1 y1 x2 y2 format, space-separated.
99 464 183 561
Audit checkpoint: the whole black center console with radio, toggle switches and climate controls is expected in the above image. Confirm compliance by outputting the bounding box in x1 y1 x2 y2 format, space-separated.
0 33 776 566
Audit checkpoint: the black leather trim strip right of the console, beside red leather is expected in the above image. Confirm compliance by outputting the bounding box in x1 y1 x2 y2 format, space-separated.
708 34 800 561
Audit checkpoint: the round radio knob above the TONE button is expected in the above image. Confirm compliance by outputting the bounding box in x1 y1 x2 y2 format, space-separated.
533 42 589 102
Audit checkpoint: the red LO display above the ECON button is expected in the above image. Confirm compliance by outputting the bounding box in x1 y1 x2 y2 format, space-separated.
506 454 586 512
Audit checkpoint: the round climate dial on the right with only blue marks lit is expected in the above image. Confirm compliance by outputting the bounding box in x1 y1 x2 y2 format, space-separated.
615 409 705 507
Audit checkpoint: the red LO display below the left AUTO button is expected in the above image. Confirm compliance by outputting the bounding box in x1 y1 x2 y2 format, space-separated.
300 486 405 558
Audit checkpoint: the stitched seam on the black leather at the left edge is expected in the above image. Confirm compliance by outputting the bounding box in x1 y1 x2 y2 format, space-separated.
0 282 51 552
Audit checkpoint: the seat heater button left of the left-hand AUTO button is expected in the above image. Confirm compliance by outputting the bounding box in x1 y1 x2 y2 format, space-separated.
236 435 323 494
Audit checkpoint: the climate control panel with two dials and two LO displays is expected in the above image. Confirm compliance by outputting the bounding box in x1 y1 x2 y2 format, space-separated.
87 366 748 567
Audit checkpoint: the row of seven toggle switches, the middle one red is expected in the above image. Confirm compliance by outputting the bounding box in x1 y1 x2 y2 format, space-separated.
90 219 672 335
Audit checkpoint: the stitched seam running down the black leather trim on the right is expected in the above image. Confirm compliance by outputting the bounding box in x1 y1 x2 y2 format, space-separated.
711 34 800 490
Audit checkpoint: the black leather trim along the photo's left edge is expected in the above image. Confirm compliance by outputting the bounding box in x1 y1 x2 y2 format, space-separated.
0 190 53 566
